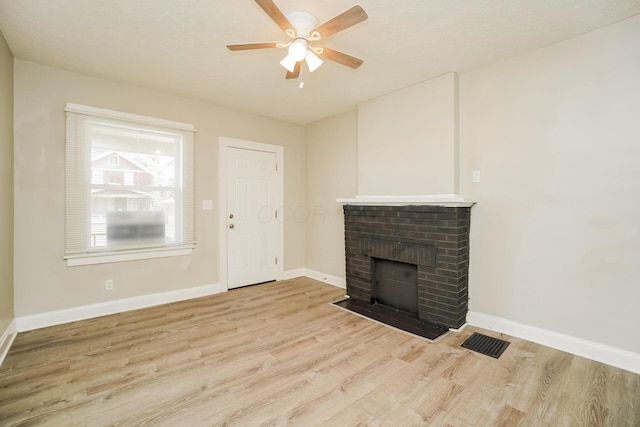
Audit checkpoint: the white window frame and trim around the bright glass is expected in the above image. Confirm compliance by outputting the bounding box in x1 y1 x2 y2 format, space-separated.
64 103 196 267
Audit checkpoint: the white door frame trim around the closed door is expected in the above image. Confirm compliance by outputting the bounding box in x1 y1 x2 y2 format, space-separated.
218 136 284 292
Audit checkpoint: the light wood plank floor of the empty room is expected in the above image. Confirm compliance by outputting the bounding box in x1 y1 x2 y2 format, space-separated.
0 278 640 427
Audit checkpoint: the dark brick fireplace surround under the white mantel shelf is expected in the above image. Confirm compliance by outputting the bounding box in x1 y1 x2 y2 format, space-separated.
344 204 471 328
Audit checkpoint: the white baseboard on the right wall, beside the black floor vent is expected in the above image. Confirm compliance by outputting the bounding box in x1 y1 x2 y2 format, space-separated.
467 311 640 374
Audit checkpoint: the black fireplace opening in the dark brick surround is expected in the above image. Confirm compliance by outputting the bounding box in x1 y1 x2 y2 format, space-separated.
371 258 419 318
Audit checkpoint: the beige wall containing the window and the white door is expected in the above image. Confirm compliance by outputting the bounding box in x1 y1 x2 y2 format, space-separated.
14 60 305 316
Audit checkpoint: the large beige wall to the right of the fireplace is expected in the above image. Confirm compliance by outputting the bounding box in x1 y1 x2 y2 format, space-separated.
460 16 640 353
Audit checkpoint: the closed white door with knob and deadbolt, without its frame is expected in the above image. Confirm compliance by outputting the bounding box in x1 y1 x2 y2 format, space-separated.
226 147 279 289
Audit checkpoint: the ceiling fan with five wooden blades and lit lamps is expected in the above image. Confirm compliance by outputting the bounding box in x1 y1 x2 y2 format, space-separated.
227 0 368 79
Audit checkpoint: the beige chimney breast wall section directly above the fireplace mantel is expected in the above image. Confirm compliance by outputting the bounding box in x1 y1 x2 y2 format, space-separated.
358 73 459 196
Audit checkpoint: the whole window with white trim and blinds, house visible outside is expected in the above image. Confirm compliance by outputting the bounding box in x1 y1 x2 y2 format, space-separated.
65 104 195 266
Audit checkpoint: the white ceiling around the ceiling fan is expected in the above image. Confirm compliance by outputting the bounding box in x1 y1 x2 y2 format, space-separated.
0 0 640 124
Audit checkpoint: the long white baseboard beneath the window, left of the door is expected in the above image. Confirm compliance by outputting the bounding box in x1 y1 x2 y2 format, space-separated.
15 283 221 332
